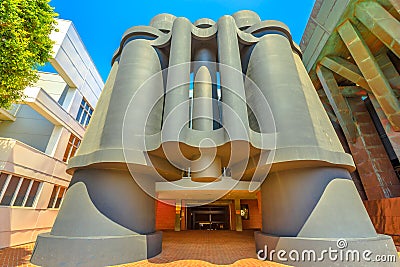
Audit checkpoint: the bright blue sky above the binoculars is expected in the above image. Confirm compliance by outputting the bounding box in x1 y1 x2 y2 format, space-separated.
50 0 314 81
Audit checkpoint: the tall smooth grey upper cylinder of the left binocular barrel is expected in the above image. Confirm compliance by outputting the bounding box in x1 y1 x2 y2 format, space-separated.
92 39 164 151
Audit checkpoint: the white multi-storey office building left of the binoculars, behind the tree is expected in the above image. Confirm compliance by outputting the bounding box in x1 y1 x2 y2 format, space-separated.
0 20 104 248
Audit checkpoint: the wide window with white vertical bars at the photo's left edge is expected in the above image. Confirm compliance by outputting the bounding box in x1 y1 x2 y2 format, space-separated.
0 173 41 207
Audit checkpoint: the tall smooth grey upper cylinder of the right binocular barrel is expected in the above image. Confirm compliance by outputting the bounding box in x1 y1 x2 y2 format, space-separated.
246 34 318 147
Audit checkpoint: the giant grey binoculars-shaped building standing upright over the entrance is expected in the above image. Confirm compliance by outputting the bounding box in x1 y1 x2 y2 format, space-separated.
32 11 395 266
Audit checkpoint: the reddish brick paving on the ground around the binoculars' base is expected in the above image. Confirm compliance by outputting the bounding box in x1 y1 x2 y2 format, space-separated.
0 231 284 267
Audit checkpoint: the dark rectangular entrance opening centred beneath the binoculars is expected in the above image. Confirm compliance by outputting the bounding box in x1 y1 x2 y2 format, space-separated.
187 206 230 230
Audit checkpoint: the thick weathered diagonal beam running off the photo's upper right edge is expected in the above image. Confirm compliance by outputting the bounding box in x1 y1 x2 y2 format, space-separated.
355 1 400 57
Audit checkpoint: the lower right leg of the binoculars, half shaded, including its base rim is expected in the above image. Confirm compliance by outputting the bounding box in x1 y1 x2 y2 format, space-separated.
255 167 396 266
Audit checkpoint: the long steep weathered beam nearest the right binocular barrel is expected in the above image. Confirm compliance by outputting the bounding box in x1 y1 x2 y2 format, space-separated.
316 65 357 143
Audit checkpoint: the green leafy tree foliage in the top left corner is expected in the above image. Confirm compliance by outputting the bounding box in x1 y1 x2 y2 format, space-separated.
0 0 57 108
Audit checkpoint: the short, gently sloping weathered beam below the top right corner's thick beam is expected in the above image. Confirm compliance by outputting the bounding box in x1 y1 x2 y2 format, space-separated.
320 57 371 91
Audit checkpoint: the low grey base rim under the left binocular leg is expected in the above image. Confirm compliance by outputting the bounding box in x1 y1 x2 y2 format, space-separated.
31 232 162 266
